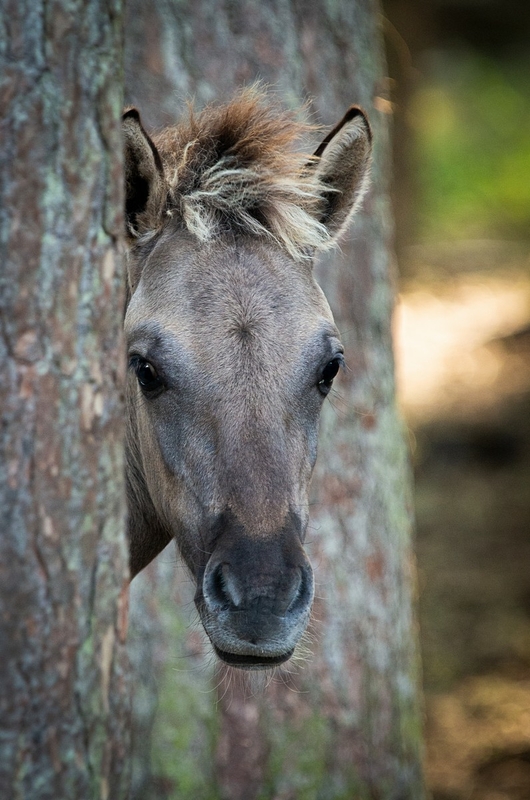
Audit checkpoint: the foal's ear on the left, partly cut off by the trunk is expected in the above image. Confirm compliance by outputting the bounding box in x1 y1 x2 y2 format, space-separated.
122 108 166 239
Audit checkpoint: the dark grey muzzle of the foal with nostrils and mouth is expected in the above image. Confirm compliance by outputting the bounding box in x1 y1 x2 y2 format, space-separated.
195 526 314 669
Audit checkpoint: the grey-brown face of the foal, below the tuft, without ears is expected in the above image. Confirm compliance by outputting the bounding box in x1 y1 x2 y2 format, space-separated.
125 233 343 668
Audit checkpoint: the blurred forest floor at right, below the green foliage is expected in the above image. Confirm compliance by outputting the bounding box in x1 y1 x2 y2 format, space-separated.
396 242 530 800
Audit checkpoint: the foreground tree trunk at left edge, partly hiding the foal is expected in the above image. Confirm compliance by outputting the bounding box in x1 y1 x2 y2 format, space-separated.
0 0 129 800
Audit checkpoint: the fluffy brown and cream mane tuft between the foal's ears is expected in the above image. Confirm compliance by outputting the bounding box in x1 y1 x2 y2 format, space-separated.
153 88 330 260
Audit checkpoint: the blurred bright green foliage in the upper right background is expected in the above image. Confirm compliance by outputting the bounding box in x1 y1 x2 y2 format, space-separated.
411 49 530 240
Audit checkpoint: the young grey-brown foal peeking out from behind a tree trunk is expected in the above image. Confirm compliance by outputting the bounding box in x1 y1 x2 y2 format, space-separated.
122 87 372 670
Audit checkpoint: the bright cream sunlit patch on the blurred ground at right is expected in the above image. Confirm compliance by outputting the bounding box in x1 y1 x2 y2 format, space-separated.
395 274 530 422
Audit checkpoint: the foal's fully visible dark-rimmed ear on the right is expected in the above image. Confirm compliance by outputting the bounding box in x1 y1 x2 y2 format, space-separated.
314 106 372 238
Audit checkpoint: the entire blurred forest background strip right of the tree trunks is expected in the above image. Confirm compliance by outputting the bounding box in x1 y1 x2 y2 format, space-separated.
383 0 530 800
